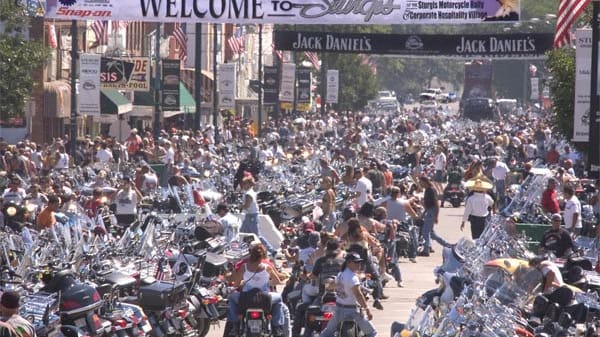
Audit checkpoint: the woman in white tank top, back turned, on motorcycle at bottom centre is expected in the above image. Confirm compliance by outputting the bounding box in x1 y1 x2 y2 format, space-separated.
223 244 289 337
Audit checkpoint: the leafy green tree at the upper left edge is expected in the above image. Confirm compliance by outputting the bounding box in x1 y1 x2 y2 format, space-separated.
0 1 47 121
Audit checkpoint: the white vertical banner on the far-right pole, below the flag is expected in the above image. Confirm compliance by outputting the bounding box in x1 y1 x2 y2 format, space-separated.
572 29 592 142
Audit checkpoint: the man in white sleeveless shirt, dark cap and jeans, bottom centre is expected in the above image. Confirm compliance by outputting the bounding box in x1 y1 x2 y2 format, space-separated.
320 253 377 337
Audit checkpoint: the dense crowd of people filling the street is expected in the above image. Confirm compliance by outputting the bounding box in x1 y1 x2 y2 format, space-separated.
0 103 600 337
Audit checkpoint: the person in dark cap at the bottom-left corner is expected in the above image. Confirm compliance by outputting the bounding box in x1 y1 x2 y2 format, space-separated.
0 290 36 337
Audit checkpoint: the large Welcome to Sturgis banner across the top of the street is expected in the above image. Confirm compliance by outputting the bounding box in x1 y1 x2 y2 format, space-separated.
45 0 520 25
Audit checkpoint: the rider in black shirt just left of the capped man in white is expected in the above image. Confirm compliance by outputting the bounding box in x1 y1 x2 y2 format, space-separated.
292 238 344 337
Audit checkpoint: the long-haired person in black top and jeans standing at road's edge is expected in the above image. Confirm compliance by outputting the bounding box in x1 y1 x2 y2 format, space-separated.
419 176 450 256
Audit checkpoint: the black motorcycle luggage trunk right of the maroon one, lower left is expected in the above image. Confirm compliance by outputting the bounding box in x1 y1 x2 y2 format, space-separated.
138 281 186 311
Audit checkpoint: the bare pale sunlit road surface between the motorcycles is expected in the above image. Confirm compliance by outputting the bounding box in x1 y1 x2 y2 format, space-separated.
208 203 471 337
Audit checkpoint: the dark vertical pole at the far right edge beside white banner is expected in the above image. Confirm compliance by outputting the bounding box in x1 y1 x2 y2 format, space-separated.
587 0 600 179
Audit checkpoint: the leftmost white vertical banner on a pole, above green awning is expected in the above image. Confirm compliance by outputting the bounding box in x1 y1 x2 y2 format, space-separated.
77 54 101 116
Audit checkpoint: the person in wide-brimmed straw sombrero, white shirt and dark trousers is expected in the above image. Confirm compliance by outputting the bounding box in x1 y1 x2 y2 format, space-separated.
460 177 494 240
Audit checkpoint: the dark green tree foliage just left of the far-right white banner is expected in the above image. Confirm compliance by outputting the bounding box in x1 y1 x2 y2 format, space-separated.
546 48 584 150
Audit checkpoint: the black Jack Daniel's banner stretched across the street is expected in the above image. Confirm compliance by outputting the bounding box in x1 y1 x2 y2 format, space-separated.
274 31 554 59
